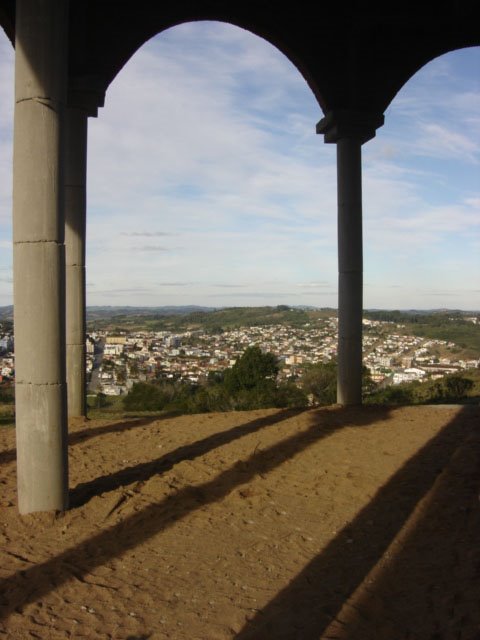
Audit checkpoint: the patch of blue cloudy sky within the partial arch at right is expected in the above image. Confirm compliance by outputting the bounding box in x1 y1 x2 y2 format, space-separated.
364 47 480 310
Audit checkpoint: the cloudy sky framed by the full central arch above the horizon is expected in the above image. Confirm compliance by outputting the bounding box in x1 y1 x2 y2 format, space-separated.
87 22 337 307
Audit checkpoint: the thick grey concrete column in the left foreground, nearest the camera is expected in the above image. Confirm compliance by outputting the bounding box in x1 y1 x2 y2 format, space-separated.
13 0 68 514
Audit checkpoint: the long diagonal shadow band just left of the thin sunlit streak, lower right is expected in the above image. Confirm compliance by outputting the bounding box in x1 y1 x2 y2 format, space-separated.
236 408 480 640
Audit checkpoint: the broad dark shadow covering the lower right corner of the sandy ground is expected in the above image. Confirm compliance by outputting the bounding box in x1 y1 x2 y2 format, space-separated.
236 407 480 640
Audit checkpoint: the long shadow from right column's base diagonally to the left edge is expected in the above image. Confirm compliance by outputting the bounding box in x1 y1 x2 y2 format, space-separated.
0 408 388 620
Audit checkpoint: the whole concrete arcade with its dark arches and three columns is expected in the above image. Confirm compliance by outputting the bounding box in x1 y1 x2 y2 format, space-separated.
0 0 480 513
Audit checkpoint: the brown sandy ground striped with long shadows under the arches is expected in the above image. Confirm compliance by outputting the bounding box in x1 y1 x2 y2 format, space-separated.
0 406 480 640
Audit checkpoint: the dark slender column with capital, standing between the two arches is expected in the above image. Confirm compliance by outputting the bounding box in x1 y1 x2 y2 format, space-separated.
317 111 383 406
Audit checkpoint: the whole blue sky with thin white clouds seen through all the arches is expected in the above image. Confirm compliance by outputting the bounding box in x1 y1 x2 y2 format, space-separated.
0 22 480 310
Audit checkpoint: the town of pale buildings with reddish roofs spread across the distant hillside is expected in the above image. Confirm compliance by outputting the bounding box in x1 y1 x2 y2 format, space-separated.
87 318 479 395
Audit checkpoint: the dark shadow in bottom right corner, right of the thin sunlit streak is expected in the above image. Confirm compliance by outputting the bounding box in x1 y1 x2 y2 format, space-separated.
326 422 480 640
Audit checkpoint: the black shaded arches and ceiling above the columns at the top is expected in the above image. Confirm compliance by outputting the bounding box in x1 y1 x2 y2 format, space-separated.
0 0 480 114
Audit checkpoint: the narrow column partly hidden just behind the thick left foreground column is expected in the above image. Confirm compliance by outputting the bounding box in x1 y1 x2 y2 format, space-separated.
65 106 88 416
